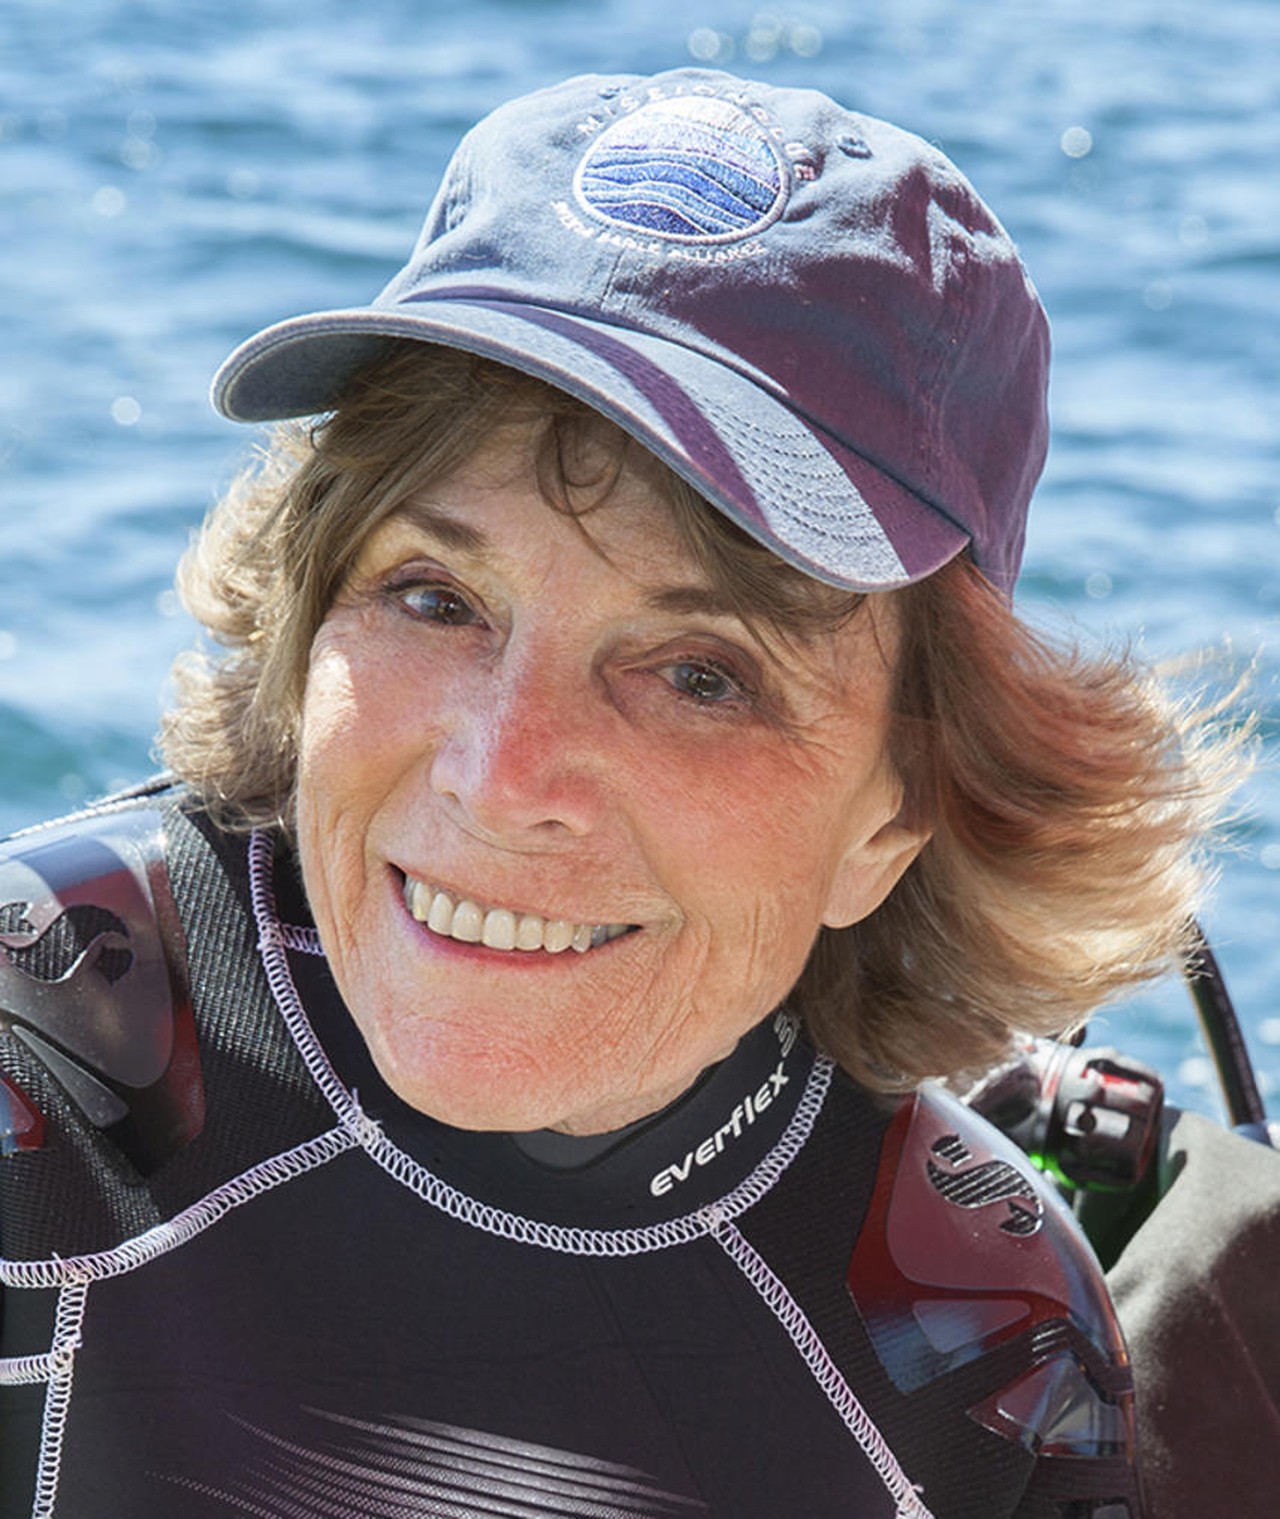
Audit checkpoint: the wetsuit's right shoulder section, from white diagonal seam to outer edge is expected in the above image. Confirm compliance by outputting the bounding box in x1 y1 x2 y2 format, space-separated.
744 1072 1140 1516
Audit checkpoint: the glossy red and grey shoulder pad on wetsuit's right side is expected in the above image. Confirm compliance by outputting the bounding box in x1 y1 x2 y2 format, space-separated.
847 1085 1137 1513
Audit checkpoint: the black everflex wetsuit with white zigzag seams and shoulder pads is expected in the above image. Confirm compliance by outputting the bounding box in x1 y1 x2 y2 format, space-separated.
0 794 1139 1519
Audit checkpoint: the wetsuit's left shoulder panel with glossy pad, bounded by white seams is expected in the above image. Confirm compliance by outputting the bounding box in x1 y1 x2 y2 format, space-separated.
0 778 331 1259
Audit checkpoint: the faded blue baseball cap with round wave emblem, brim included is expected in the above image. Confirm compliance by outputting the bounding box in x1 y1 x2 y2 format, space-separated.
214 68 1049 591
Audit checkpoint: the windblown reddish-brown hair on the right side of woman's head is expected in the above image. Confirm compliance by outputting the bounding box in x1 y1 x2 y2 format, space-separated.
813 557 1245 1086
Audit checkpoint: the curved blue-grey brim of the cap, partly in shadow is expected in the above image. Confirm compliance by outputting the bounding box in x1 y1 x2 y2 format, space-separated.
213 298 969 591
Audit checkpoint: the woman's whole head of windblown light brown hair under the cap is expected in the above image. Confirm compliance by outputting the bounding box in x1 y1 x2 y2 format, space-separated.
161 342 1239 1089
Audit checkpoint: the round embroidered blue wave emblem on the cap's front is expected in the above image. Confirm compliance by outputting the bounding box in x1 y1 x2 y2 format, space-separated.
575 96 787 242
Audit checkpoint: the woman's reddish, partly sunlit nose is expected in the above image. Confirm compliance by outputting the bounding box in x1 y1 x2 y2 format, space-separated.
431 661 604 845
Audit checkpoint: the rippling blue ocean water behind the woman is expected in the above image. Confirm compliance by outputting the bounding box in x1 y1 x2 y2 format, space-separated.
0 0 1280 1112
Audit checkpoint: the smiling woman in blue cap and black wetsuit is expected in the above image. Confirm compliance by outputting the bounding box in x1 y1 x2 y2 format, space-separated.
0 70 1219 1519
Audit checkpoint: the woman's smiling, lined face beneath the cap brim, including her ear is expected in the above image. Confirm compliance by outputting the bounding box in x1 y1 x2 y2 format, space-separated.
298 430 920 1133
